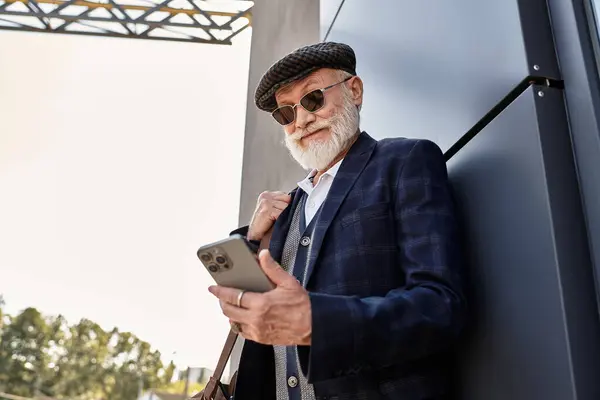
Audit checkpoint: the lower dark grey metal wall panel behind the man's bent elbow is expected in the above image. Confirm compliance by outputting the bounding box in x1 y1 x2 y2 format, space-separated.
448 88 600 400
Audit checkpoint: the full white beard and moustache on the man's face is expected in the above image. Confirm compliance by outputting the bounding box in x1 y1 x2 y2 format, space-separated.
285 91 359 171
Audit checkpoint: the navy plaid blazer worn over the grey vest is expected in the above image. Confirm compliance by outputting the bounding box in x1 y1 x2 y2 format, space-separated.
234 132 466 400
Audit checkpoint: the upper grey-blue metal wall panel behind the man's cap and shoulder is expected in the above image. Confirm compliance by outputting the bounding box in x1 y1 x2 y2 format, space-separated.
328 0 556 150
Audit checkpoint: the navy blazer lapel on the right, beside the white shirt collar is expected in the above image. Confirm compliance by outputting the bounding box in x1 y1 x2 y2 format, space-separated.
304 132 377 286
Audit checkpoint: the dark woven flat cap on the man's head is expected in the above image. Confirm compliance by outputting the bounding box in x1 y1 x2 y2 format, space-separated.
254 42 356 112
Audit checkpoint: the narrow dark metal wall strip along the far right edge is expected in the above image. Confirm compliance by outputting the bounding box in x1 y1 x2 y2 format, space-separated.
548 0 600 316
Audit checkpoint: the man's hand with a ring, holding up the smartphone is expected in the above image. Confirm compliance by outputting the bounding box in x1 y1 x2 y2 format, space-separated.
208 250 312 346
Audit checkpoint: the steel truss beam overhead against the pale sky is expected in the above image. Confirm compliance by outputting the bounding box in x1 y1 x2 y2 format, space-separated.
0 0 253 45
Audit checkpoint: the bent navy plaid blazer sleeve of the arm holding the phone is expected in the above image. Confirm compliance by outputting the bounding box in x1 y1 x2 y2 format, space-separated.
299 140 465 382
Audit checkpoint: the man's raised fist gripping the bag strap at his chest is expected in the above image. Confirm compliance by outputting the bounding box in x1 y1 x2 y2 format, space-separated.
247 192 292 240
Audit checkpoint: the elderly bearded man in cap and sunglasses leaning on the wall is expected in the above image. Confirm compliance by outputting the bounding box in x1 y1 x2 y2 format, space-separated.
209 42 465 400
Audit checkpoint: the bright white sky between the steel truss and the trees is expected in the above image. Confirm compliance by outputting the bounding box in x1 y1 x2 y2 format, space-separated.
0 26 251 374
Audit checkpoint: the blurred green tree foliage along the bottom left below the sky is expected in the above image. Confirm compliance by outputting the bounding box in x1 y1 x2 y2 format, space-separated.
0 304 175 400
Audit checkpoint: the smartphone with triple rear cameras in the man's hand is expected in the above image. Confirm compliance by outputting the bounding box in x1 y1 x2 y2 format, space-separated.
196 235 275 293
